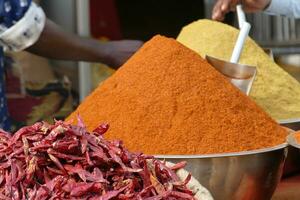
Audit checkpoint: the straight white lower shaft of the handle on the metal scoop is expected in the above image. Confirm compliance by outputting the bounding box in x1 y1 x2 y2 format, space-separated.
230 22 251 63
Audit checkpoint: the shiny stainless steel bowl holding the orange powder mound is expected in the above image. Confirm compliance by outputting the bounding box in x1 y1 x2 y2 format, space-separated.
156 143 288 200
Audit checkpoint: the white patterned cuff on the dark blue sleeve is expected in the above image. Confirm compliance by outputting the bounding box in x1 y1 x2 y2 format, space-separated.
0 3 46 51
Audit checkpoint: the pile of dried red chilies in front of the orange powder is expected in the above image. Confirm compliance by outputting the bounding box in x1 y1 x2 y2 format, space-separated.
0 121 194 200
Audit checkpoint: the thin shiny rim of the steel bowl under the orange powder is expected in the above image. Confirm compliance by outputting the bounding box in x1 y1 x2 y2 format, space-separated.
154 142 288 159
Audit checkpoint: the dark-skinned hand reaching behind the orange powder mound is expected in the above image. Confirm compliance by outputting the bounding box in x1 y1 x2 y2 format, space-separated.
106 40 143 68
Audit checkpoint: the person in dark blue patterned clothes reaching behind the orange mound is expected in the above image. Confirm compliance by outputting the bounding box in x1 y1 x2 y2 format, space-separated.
0 0 142 130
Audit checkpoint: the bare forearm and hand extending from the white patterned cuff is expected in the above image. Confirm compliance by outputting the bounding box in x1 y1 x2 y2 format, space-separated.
27 19 142 67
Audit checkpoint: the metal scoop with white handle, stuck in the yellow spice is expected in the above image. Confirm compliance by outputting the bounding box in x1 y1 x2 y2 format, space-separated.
206 5 256 95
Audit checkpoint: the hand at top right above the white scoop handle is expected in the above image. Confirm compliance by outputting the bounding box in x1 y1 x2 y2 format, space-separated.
212 0 271 21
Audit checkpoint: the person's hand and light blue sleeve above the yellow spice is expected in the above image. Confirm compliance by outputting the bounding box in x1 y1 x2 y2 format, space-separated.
212 0 300 21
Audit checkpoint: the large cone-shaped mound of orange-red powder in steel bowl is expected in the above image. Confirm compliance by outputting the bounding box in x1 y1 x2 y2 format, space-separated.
67 36 287 154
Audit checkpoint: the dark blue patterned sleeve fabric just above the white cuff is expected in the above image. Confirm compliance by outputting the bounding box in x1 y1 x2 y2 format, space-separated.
0 0 32 28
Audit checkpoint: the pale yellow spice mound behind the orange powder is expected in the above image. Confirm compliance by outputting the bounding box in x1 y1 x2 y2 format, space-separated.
177 20 300 120
